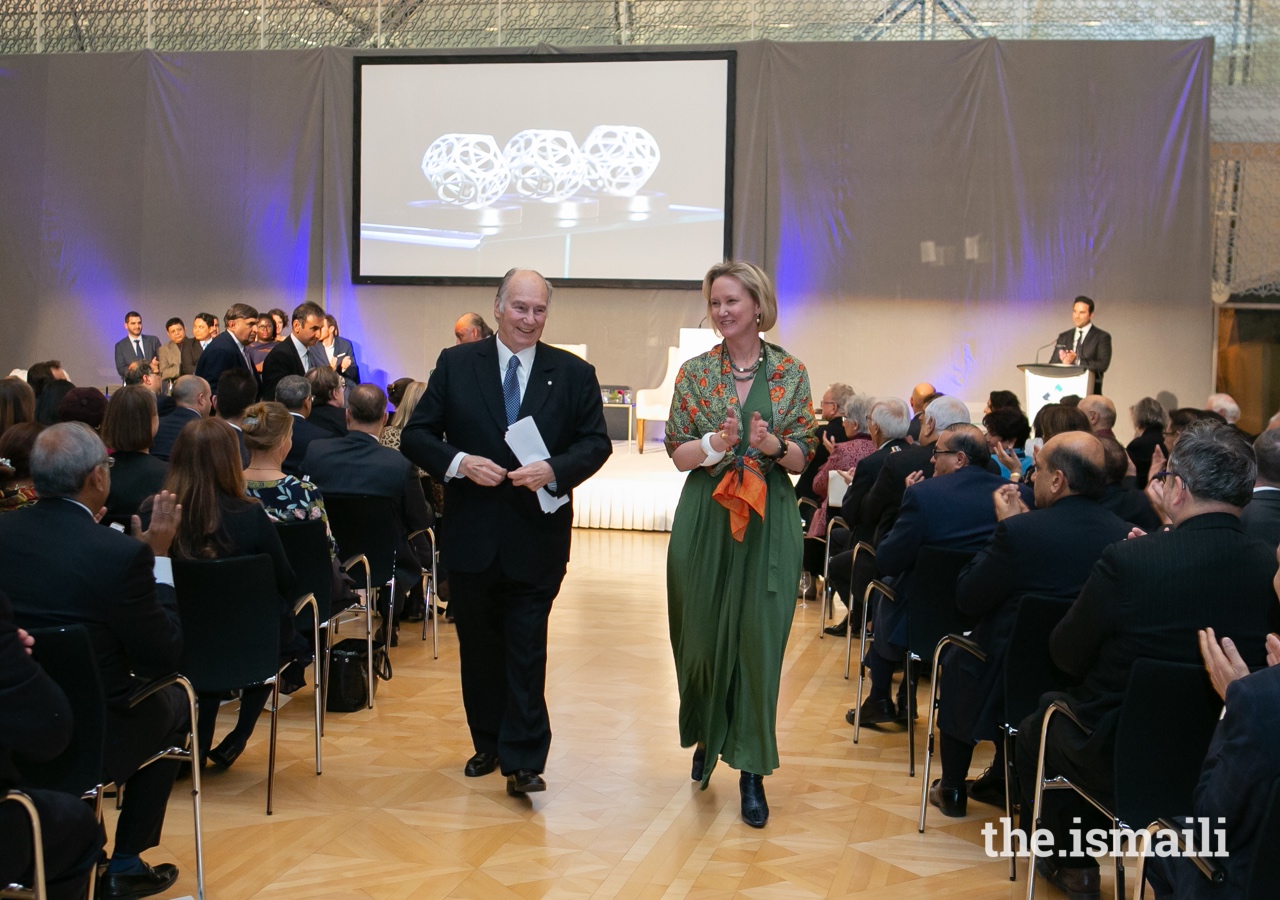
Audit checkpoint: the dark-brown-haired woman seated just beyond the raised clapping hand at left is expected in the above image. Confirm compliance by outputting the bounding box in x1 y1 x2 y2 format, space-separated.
101 384 169 526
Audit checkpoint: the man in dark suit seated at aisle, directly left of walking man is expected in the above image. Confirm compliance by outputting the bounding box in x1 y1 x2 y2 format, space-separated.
302 384 435 647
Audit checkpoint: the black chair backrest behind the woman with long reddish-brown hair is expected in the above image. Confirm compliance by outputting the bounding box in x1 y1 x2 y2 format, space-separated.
173 553 282 693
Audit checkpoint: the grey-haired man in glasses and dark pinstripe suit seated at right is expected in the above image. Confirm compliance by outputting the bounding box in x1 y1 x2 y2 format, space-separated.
1016 422 1280 896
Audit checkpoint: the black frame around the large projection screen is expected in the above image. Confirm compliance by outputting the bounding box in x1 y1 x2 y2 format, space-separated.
348 50 737 289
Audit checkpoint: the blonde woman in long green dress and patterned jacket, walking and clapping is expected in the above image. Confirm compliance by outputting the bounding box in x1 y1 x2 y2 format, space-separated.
667 261 814 828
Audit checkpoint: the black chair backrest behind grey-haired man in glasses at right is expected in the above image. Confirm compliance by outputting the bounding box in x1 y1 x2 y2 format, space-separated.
1114 659 1222 828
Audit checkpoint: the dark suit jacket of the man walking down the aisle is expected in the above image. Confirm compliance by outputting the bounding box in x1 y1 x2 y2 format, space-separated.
401 337 613 585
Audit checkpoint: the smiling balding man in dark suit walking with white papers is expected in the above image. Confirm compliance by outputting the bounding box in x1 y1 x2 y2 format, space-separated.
401 269 612 794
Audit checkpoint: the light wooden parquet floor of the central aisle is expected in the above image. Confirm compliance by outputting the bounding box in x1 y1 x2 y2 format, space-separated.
132 530 1100 900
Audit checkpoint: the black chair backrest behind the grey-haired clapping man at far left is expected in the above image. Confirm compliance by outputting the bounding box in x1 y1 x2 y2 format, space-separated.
15 625 106 796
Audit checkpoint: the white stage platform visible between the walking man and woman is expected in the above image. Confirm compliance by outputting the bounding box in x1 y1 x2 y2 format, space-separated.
573 440 686 531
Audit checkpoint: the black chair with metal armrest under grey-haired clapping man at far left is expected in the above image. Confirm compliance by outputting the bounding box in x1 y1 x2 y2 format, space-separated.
19 625 205 900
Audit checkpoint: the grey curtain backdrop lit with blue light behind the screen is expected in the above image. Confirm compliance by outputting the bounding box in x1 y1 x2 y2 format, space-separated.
0 40 1212 425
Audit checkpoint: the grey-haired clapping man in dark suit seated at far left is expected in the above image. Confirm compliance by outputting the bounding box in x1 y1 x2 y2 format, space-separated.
0 422 188 900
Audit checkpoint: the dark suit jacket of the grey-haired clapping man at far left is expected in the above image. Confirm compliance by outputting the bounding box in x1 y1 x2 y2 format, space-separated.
0 499 182 707
